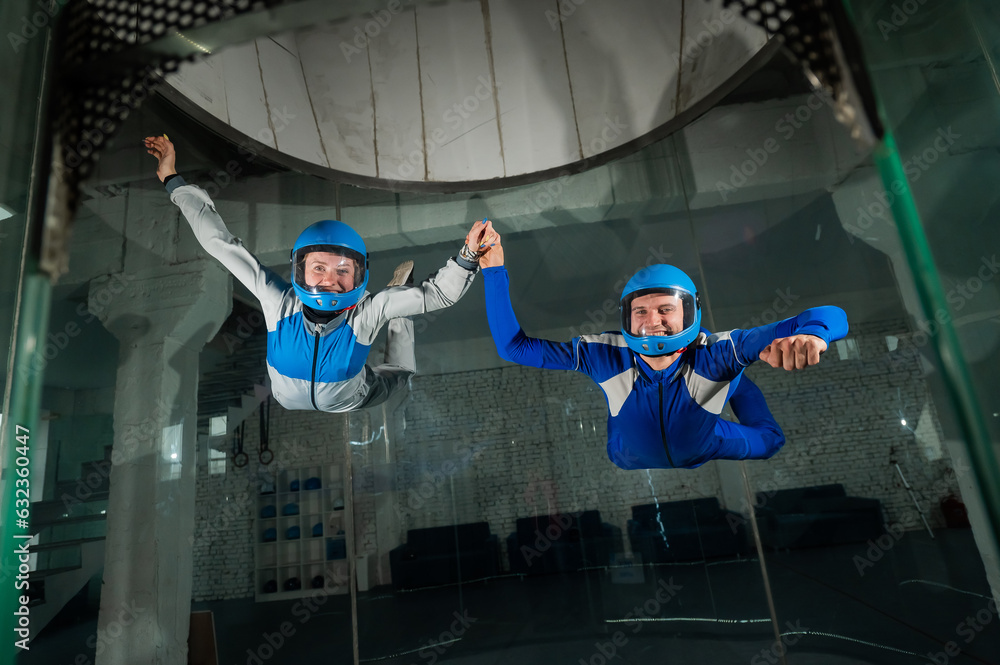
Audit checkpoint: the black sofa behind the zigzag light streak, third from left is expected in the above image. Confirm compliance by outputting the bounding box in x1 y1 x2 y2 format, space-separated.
628 497 749 563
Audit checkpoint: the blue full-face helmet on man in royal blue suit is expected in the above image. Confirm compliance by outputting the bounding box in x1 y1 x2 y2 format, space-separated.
620 263 701 356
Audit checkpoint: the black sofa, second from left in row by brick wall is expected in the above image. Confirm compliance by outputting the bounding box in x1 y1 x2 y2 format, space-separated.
507 510 622 575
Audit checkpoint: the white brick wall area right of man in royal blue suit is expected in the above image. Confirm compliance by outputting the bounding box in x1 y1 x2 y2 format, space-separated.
747 321 958 529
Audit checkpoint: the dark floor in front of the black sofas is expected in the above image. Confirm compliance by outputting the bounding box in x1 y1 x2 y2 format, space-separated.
19 530 1000 665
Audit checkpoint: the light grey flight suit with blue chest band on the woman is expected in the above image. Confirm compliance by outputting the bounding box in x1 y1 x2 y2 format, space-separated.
166 176 478 413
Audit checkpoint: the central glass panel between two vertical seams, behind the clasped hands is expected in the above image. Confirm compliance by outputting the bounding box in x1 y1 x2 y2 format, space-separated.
341 134 774 663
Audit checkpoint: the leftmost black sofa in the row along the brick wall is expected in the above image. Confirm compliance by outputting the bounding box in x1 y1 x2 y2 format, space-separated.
389 522 500 591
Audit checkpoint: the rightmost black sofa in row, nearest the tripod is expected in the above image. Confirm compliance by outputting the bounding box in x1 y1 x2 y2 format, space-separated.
756 484 885 549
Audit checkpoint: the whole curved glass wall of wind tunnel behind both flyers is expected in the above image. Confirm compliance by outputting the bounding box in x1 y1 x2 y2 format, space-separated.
23 11 1000 665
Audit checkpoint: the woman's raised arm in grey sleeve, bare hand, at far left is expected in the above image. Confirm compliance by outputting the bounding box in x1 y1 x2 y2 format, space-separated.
145 136 288 305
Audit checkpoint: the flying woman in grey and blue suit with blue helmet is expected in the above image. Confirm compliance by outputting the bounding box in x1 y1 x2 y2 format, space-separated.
145 136 493 412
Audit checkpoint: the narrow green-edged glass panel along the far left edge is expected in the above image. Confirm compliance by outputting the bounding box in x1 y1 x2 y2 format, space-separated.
0 0 50 661
